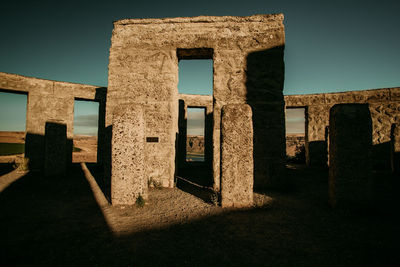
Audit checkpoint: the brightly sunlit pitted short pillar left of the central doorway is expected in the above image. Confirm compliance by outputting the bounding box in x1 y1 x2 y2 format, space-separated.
111 104 148 205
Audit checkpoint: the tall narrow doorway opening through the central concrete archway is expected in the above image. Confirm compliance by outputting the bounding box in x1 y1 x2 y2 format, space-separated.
177 48 214 197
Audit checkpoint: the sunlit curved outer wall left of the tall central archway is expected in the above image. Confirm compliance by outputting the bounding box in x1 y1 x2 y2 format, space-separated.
0 72 106 170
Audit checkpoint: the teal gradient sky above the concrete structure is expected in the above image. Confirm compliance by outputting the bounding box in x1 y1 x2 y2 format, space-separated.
0 0 400 134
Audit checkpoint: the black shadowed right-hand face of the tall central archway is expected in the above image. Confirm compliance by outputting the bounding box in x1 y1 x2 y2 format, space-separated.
246 46 285 189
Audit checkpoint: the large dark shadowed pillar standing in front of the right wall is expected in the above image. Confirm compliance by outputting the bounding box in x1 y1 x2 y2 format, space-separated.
329 104 372 207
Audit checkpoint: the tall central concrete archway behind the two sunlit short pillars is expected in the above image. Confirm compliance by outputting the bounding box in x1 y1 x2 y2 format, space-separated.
106 14 285 189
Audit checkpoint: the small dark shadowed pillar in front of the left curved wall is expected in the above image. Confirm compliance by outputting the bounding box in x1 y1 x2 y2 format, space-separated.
44 121 68 176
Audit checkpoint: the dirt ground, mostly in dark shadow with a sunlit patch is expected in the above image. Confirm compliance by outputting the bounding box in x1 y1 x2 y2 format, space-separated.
0 164 399 266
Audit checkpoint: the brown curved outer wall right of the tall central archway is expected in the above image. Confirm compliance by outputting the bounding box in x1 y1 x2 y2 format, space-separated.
285 87 400 168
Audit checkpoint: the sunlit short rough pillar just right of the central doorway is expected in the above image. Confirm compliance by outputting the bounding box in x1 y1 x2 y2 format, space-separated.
221 104 254 207
